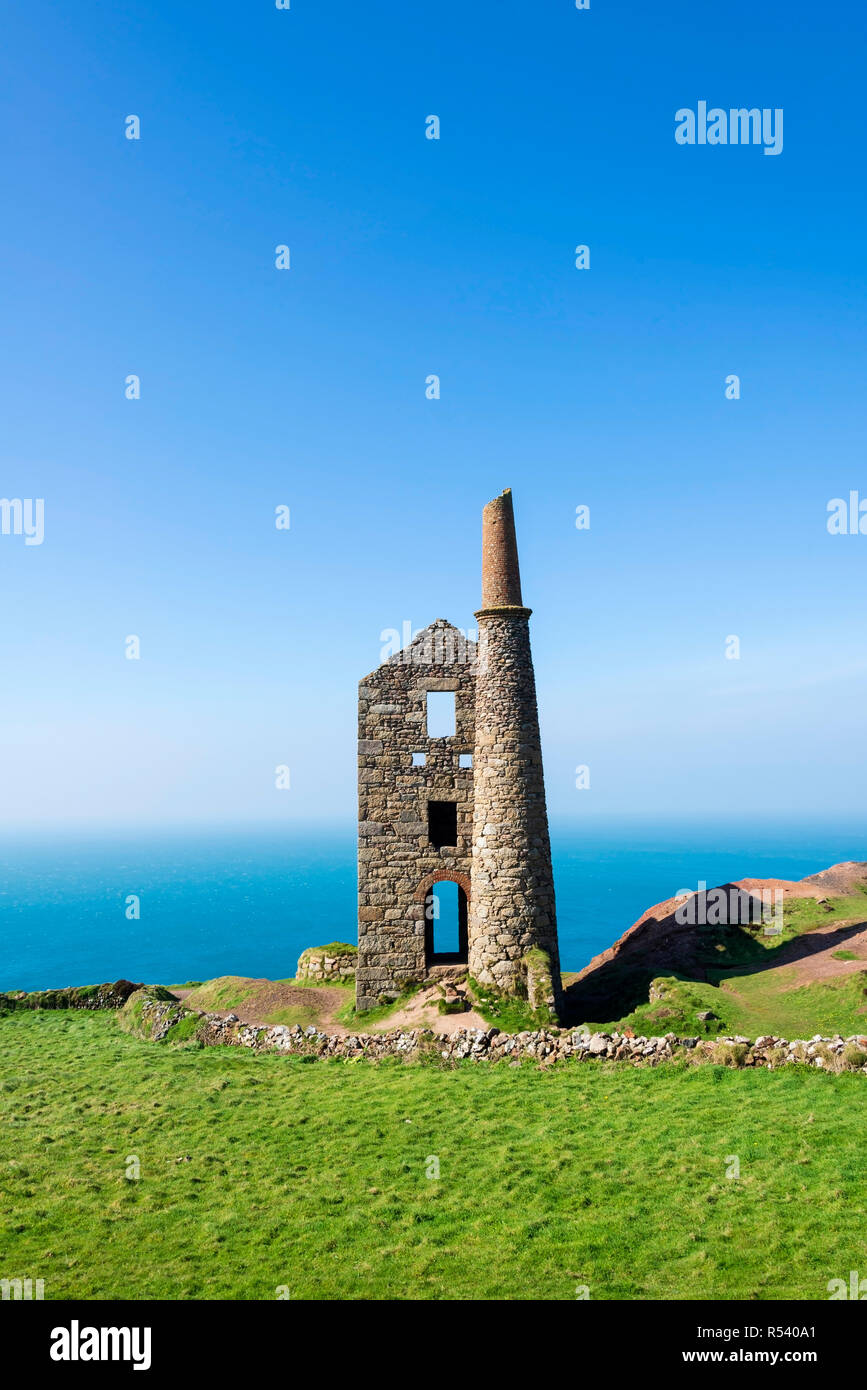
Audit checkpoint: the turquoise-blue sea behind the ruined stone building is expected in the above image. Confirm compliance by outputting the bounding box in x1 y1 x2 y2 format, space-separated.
0 820 867 990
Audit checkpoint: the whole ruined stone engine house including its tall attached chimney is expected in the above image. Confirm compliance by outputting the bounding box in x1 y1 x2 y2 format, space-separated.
356 489 560 1011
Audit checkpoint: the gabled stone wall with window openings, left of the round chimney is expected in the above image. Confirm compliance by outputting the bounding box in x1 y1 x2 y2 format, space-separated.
356 619 475 1009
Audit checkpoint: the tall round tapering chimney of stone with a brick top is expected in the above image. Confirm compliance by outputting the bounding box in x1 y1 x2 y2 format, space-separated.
468 489 561 1011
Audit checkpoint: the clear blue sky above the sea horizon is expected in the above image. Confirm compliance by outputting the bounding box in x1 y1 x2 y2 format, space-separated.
0 0 867 824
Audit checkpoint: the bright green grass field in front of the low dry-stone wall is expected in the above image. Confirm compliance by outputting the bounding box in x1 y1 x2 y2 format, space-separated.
0 1011 867 1300
